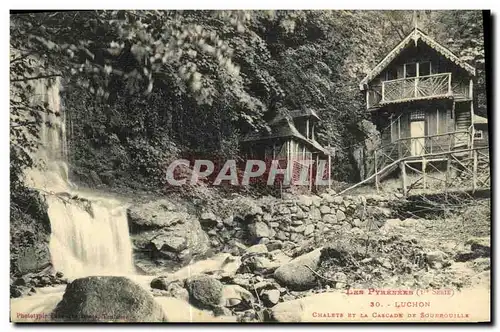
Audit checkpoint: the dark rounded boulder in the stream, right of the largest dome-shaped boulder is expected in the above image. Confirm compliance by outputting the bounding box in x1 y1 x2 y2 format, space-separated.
186 275 223 309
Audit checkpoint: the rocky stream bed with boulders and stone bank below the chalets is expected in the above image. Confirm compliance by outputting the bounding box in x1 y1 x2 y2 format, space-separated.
10 193 490 322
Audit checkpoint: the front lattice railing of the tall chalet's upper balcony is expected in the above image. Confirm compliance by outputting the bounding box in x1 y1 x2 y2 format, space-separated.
381 73 453 103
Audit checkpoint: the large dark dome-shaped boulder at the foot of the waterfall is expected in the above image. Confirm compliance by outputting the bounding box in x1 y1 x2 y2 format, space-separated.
53 277 167 322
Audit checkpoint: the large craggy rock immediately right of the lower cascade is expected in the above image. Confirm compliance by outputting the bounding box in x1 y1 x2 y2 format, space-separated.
128 200 210 273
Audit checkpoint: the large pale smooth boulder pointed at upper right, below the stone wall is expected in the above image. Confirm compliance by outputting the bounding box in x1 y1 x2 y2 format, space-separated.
274 248 321 290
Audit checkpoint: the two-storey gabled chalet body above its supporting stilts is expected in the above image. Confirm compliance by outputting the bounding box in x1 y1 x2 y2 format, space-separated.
360 28 476 159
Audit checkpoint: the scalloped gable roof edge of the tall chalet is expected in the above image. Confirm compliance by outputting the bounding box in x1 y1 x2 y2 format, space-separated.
359 28 476 90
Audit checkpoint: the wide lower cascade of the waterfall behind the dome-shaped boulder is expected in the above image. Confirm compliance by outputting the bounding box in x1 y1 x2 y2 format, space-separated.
47 196 133 276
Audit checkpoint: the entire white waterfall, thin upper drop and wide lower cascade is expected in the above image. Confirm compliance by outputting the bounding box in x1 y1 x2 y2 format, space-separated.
26 76 134 277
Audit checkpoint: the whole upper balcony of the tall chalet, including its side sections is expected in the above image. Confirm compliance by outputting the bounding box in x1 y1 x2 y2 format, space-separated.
368 73 470 107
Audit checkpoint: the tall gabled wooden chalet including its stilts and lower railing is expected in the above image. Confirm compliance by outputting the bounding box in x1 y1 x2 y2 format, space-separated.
359 28 489 194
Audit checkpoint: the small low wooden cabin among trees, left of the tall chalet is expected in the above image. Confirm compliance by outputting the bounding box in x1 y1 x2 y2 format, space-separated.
242 109 331 188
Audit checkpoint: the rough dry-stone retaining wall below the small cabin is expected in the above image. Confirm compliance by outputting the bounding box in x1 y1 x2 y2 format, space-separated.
200 191 392 254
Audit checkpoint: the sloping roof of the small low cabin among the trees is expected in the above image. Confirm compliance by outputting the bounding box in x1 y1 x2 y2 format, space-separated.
242 119 330 155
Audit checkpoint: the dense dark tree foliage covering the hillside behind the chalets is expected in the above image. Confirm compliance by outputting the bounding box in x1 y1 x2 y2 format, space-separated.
11 11 485 192
